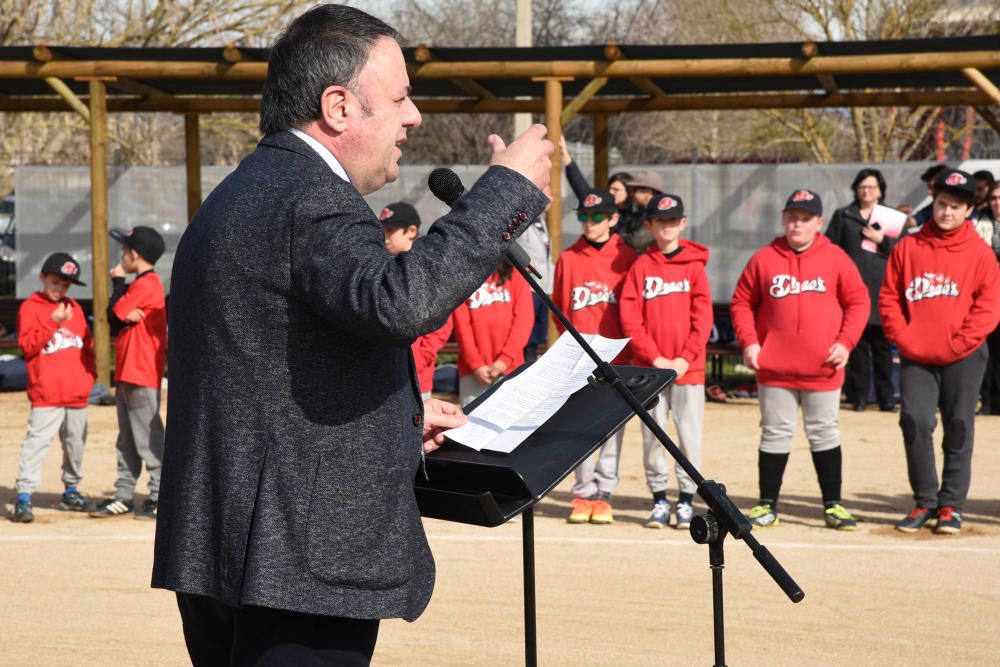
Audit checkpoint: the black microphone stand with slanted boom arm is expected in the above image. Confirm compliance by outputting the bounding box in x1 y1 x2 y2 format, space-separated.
506 250 805 667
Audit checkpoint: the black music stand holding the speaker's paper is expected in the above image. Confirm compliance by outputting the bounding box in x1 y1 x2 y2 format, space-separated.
415 366 676 667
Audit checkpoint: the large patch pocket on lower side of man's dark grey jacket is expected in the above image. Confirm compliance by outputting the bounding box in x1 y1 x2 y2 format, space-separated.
306 456 423 590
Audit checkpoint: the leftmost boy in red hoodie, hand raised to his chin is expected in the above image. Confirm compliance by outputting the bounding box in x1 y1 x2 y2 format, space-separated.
11 252 96 523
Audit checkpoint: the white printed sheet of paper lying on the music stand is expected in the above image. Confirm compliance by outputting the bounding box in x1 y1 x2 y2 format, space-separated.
445 333 628 453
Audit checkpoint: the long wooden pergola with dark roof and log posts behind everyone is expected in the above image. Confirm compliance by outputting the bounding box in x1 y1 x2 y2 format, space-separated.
0 35 1000 384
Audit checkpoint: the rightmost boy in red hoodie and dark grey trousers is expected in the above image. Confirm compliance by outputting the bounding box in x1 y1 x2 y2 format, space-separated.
879 169 1000 534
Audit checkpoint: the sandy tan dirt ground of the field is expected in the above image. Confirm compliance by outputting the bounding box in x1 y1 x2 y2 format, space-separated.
0 393 1000 667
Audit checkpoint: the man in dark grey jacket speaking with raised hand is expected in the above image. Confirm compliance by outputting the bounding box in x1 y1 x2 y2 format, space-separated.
153 5 552 665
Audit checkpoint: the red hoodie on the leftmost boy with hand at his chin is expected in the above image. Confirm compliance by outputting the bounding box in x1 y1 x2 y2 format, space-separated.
17 292 97 408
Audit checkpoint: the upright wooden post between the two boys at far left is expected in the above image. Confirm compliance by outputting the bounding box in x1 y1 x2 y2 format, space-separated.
88 79 111 387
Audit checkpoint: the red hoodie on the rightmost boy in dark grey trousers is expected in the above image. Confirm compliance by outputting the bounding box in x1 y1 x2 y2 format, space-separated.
878 221 1000 366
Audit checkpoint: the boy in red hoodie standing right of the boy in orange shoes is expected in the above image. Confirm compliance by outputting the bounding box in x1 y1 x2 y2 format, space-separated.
621 194 712 529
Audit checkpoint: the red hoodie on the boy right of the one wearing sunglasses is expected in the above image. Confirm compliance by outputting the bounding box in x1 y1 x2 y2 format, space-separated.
621 240 712 384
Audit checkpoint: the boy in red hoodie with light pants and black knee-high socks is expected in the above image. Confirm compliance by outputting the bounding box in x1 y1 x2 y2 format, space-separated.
730 190 870 530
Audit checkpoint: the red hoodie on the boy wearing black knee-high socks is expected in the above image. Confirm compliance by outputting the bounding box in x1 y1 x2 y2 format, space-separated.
730 234 870 391
